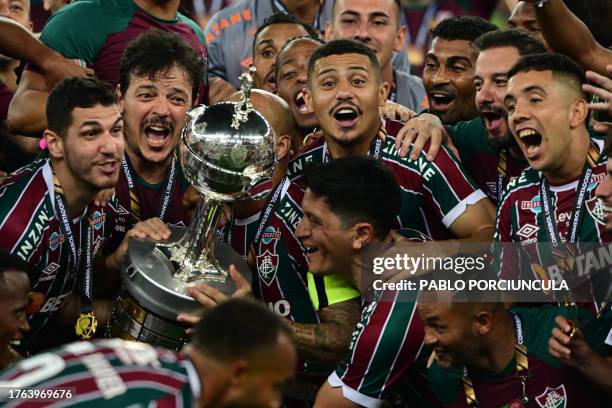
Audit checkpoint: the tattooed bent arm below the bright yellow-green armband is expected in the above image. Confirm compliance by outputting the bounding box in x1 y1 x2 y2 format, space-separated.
288 298 361 366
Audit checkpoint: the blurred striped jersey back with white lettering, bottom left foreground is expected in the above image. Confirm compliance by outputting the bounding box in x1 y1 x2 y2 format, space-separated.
0 339 201 408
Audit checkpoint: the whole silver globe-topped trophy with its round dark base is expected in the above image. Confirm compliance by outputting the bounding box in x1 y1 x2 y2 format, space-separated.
110 74 277 349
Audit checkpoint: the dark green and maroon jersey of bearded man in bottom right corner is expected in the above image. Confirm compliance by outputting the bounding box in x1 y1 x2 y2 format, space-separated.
427 306 612 408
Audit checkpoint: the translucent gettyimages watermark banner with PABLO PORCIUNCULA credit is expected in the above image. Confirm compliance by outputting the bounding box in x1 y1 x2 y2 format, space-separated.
361 241 612 303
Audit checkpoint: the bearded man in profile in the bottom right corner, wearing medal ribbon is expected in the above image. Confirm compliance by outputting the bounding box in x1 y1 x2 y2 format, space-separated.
418 301 611 407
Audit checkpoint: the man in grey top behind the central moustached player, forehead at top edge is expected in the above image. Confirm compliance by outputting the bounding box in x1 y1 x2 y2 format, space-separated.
326 0 427 112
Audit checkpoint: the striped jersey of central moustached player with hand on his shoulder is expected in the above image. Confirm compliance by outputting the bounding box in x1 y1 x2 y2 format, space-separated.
287 119 486 240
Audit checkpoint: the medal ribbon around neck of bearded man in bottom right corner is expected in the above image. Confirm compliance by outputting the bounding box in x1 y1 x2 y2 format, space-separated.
461 312 531 408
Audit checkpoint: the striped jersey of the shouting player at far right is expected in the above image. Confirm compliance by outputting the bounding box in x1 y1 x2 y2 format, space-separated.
494 138 610 279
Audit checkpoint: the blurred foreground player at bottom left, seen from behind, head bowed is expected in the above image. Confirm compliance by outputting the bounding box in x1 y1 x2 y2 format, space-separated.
0 299 297 408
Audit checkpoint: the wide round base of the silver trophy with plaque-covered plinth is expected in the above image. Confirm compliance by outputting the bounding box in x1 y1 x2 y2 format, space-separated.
110 227 251 348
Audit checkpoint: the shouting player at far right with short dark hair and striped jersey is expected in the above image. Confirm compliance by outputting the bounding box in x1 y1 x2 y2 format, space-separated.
495 54 610 280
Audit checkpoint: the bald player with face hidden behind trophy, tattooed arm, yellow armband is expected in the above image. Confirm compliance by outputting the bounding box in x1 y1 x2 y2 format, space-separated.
179 89 360 398
